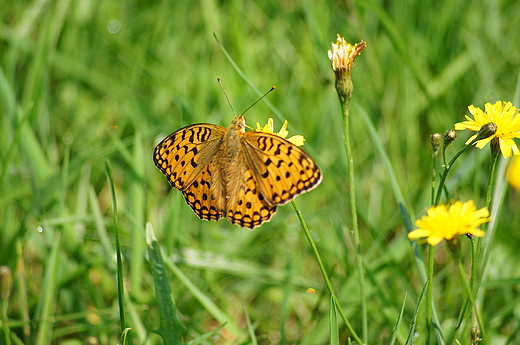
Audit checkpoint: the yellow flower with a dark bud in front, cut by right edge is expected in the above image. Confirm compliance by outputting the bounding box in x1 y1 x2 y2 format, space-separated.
455 101 520 158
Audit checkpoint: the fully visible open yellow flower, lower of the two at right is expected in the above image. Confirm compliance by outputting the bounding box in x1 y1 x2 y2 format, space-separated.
408 200 491 246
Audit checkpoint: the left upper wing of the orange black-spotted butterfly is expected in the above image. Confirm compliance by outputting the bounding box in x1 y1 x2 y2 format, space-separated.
153 123 226 189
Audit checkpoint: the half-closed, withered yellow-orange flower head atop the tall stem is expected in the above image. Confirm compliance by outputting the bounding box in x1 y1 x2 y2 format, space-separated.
328 34 366 103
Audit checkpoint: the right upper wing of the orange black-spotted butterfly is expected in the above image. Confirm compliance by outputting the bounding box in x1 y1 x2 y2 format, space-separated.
242 131 322 205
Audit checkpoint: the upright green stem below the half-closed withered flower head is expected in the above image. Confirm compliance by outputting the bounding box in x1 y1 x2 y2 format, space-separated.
340 95 368 344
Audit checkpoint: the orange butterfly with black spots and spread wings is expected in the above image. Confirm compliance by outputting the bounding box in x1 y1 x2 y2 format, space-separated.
153 115 322 229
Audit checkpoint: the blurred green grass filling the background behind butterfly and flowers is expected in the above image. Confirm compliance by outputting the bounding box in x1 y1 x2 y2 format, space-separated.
0 0 520 345
